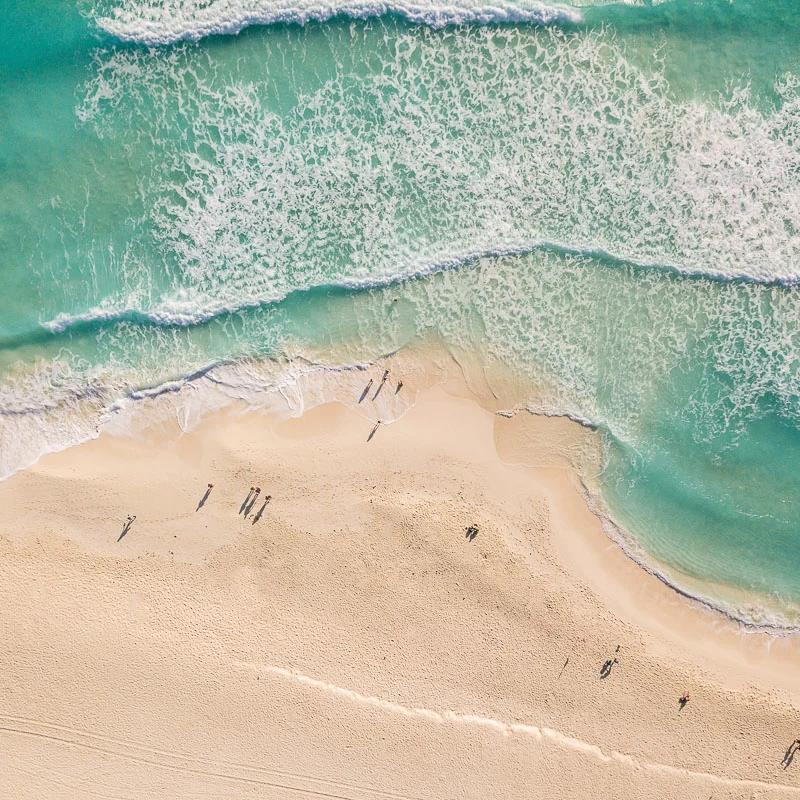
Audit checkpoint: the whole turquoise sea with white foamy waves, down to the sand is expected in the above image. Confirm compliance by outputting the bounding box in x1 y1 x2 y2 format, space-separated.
0 0 800 630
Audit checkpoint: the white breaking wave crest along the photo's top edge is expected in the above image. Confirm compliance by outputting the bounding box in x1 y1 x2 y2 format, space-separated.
95 0 582 45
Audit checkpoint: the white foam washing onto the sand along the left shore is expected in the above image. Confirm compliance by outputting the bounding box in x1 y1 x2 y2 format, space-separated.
0 346 424 481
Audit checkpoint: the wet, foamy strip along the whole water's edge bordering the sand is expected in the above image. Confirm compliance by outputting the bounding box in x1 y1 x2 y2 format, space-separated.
0 340 800 638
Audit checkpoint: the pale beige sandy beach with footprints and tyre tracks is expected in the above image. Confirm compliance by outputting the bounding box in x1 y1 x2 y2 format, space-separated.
0 376 800 800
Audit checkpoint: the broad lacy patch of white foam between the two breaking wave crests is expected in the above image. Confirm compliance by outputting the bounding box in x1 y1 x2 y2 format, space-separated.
75 24 800 342
